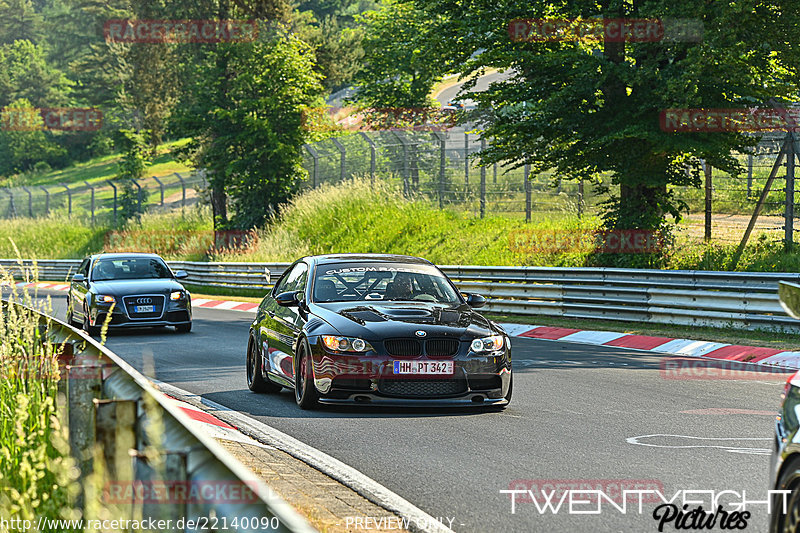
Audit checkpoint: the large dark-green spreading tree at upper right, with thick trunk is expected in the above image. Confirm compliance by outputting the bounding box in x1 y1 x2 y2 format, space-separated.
417 0 798 254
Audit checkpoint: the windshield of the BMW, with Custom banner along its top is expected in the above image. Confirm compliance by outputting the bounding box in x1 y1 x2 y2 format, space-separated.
313 263 460 304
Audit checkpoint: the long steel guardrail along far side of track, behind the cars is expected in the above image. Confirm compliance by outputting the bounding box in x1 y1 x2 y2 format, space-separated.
0 260 800 332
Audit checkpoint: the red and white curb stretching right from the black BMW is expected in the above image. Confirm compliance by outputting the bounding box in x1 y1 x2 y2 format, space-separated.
501 324 800 369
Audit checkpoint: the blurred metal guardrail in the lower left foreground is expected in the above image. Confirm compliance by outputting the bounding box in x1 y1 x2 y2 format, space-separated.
8 301 316 533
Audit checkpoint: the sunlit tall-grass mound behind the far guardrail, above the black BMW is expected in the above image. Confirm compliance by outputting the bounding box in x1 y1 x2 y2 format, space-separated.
218 179 597 265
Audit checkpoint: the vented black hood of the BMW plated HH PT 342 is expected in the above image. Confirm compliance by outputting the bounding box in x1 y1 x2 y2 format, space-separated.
311 302 501 340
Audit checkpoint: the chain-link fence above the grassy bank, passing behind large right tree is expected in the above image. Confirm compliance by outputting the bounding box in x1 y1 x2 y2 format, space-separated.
304 128 798 247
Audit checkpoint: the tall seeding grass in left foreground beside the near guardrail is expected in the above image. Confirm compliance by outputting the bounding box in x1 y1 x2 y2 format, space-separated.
0 276 80 523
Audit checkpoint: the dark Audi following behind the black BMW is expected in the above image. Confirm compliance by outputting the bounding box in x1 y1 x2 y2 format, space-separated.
67 253 192 335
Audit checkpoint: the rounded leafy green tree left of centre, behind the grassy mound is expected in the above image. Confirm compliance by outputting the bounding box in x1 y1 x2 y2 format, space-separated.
180 30 321 229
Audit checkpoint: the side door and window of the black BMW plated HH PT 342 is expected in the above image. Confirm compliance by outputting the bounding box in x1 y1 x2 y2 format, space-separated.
259 261 308 385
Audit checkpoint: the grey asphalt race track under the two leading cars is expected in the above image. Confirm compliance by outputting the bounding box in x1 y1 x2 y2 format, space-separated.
32 293 785 533
